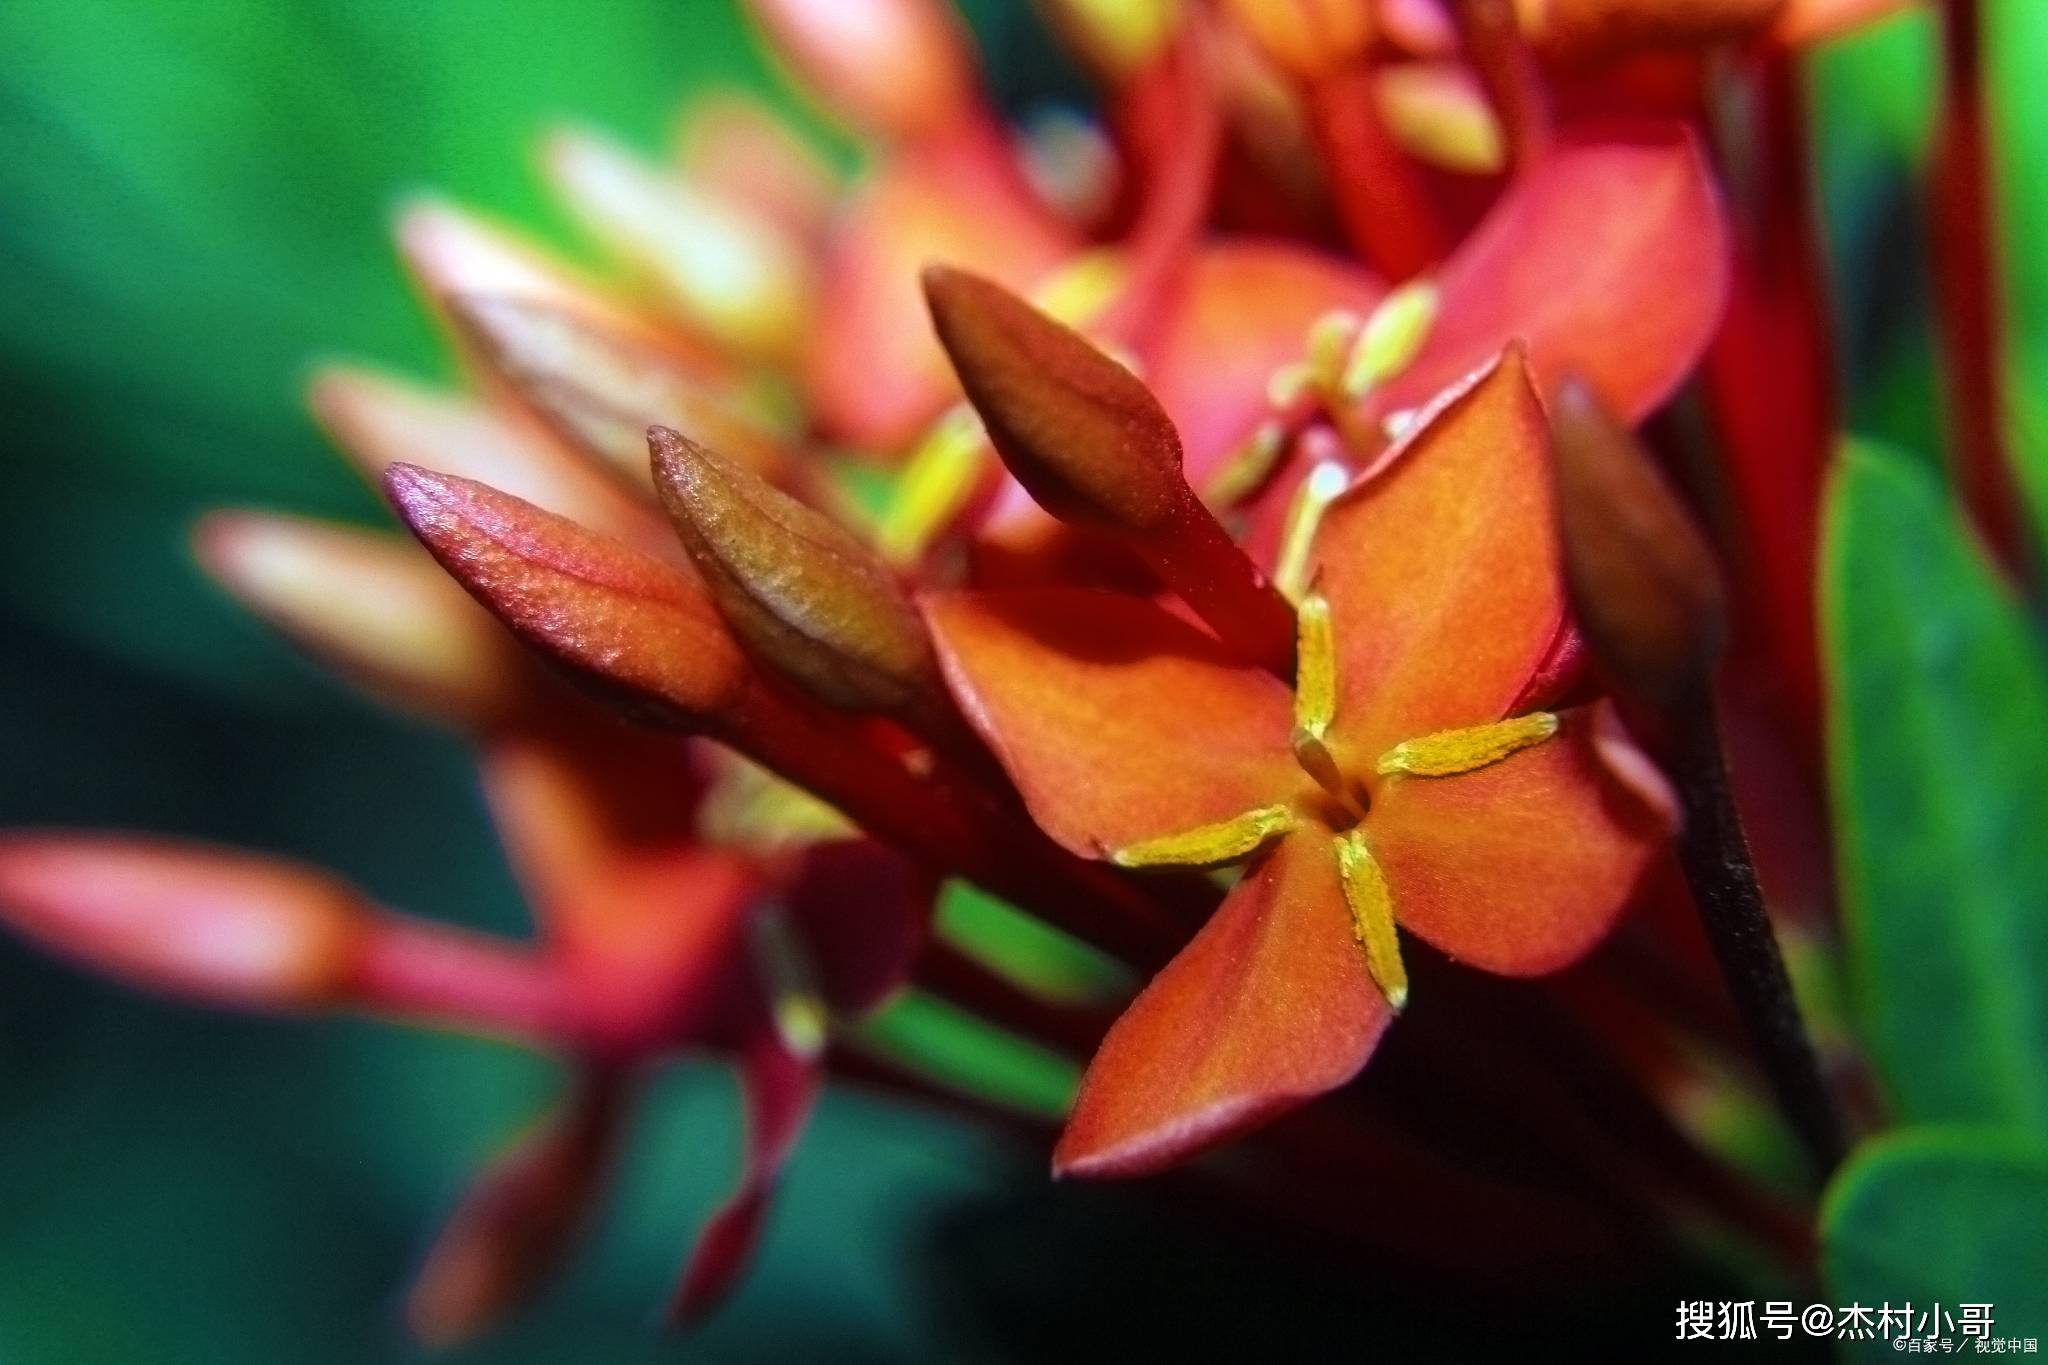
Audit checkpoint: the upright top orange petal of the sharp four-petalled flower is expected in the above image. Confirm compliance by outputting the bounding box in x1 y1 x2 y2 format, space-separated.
1315 352 1565 772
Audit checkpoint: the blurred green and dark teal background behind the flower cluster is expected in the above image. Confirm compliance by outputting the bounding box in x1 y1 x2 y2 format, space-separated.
0 0 2048 1365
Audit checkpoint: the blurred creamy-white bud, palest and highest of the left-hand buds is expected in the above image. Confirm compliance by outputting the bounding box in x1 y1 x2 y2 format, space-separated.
545 131 811 358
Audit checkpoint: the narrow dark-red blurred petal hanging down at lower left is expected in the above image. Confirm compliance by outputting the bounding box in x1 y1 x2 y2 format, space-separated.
670 1036 823 1322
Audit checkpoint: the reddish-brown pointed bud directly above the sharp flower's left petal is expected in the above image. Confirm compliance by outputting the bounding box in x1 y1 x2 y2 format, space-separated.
924 266 1190 530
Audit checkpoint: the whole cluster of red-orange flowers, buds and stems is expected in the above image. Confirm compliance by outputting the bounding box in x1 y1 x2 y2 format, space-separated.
0 0 1933 1340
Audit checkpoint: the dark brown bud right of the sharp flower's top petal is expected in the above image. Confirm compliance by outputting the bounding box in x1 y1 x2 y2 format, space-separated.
1550 377 1726 710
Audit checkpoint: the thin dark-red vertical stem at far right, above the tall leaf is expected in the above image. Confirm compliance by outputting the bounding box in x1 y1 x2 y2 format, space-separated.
1929 0 2028 577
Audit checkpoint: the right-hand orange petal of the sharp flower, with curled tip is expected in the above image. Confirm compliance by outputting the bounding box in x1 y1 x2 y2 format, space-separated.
1366 708 1671 976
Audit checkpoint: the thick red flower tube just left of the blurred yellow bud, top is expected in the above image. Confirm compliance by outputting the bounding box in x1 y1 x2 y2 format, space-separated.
1307 61 1444 280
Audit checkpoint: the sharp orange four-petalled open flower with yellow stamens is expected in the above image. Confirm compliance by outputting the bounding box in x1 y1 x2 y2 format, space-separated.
928 352 1669 1175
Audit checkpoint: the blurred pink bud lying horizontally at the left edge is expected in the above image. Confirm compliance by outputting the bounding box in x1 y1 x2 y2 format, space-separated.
0 833 369 1009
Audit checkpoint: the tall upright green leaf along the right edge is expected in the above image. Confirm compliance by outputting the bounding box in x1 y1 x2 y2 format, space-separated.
1823 448 2048 1130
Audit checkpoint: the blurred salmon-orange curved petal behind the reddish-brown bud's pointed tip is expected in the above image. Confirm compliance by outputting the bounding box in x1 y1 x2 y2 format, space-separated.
805 143 1079 450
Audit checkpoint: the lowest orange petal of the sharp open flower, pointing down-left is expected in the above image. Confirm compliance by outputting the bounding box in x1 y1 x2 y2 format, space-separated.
1053 831 1393 1175
